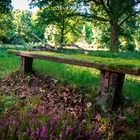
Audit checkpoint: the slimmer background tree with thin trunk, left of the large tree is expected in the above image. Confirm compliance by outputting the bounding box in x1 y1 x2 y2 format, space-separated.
32 0 80 46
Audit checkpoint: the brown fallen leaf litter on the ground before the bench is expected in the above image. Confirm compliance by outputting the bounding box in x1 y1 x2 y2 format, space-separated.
0 71 140 140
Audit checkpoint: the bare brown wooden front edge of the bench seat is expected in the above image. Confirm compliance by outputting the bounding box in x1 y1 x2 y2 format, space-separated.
10 51 140 75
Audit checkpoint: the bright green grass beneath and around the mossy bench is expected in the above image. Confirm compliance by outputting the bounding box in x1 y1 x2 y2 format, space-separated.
0 45 140 103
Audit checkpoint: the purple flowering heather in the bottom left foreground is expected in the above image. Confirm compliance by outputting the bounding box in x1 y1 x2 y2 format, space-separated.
0 106 101 140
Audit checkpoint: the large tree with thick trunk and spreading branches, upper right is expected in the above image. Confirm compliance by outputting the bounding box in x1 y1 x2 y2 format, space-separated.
78 0 140 52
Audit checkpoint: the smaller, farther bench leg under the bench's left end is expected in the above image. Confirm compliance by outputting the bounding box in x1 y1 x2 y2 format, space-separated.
21 57 33 73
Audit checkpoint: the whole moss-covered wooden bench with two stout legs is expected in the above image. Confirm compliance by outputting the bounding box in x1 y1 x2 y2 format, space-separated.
9 50 140 112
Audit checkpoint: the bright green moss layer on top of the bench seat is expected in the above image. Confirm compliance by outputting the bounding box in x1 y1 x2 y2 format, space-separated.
10 51 140 69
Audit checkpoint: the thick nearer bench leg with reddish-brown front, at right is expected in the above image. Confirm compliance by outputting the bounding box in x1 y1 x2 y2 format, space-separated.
97 70 125 112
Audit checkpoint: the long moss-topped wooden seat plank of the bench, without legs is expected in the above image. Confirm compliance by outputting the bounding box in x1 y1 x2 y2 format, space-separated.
9 50 140 75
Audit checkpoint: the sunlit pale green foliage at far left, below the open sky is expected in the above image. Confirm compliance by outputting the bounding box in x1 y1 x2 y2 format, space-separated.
0 10 37 45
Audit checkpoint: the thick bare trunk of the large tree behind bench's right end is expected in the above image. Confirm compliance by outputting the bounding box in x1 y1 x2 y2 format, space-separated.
110 21 119 52
